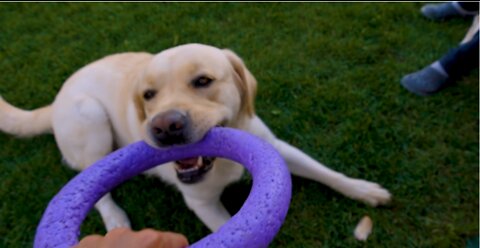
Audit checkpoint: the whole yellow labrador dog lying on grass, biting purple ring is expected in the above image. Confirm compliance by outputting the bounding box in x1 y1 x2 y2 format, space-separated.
0 44 390 231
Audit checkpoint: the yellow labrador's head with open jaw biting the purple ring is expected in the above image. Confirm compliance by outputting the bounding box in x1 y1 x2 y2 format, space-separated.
134 44 256 183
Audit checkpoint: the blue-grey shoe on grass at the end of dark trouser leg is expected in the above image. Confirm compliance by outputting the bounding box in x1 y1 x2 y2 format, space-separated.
400 65 449 96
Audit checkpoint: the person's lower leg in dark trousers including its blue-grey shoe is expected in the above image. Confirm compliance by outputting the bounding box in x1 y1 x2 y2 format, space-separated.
400 32 479 96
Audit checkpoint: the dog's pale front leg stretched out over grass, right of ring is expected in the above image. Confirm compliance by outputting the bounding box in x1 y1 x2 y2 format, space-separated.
272 139 390 206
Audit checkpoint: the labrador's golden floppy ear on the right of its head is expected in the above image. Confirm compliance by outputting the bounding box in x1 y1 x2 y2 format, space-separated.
223 49 257 117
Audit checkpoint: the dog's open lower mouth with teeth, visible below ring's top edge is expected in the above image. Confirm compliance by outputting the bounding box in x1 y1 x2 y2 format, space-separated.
175 157 215 184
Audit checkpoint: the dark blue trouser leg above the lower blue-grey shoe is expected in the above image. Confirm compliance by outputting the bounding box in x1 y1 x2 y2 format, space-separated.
440 31 479 78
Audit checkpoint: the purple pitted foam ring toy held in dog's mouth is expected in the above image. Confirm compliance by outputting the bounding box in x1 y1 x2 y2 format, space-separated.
34 128 291 248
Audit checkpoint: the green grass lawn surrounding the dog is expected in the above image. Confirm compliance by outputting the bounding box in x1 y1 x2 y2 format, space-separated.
0 3 479 247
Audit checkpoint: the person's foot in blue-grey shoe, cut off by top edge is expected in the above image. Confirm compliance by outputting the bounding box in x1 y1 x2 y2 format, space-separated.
421 2 479 21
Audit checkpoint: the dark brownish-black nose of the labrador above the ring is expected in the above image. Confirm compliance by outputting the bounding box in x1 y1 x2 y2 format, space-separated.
150 110 189 146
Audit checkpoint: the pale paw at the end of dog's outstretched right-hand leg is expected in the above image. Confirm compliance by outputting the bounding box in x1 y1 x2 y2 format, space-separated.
343 179 391 207
